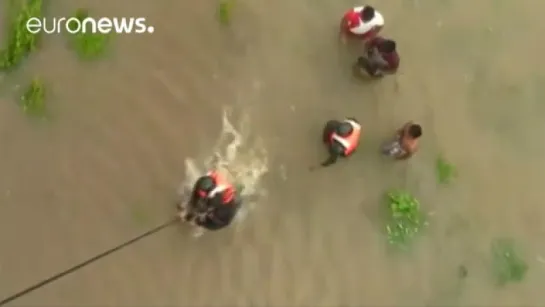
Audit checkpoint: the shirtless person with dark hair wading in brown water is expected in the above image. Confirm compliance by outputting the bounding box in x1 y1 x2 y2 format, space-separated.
382 121 422 160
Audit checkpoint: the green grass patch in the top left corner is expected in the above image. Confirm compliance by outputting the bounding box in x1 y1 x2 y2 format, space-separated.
0 0 42 70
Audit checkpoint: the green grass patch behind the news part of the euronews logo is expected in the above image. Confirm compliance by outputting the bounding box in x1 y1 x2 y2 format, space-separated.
69 9 111 60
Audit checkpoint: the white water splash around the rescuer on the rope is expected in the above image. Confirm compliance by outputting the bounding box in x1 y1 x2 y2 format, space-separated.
179 110 268 236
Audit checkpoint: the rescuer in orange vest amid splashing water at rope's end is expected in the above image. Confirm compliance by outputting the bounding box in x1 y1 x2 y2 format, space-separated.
180 171 241 230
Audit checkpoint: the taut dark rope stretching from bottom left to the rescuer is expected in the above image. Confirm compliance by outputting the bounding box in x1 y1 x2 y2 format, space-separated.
0 217 179 306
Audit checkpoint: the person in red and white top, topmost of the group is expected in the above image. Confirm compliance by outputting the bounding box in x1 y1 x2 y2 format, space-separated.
339 5 384 42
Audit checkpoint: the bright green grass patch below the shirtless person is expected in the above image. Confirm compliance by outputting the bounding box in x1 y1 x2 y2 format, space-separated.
386 190 428 246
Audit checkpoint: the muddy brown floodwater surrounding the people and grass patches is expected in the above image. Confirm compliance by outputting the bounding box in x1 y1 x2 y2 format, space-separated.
0 0 545 306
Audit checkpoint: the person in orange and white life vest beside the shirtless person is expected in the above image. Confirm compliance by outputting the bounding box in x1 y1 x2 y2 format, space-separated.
322 118 361 167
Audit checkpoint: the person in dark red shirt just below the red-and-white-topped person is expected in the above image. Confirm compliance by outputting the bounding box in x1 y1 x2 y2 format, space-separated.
358 36 399 77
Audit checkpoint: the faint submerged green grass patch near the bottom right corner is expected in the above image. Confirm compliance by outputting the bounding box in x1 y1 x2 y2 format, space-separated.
492 239 528 286
